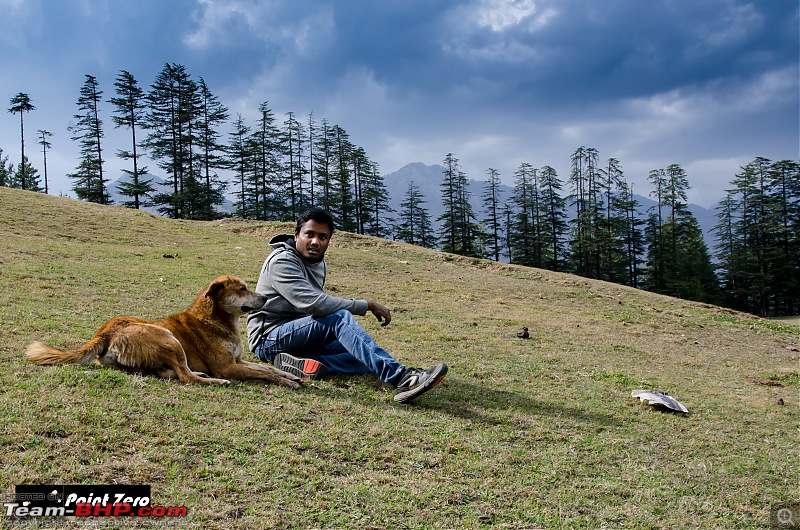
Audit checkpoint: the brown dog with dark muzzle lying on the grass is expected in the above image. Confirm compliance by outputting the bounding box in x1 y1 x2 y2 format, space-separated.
25 276 300 388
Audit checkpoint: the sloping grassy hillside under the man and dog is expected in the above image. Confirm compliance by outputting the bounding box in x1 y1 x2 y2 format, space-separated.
0 188 800 529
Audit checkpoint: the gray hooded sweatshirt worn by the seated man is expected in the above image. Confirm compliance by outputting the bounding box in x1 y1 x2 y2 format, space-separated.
247 234 368 351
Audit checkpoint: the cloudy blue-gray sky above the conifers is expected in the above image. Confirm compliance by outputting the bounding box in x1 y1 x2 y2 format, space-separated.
0 0 800 206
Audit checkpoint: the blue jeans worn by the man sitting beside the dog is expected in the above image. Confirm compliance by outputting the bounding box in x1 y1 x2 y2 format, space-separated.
253 309 405 383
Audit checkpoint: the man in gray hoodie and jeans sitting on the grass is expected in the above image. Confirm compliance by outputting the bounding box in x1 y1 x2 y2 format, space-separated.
247 208 447 403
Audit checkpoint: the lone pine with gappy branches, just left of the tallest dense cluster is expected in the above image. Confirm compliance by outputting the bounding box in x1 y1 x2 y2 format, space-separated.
109 70 155 210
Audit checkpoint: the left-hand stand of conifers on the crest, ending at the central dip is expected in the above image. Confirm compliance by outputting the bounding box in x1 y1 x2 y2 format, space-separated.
0 63 389 232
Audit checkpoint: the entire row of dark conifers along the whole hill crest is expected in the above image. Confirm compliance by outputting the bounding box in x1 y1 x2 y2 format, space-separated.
0 70 800 316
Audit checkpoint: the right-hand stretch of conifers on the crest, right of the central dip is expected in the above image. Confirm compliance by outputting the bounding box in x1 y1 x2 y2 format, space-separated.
395 147 800 316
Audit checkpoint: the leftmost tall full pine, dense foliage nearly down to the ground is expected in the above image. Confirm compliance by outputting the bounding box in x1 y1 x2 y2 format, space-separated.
68 74 110 204
